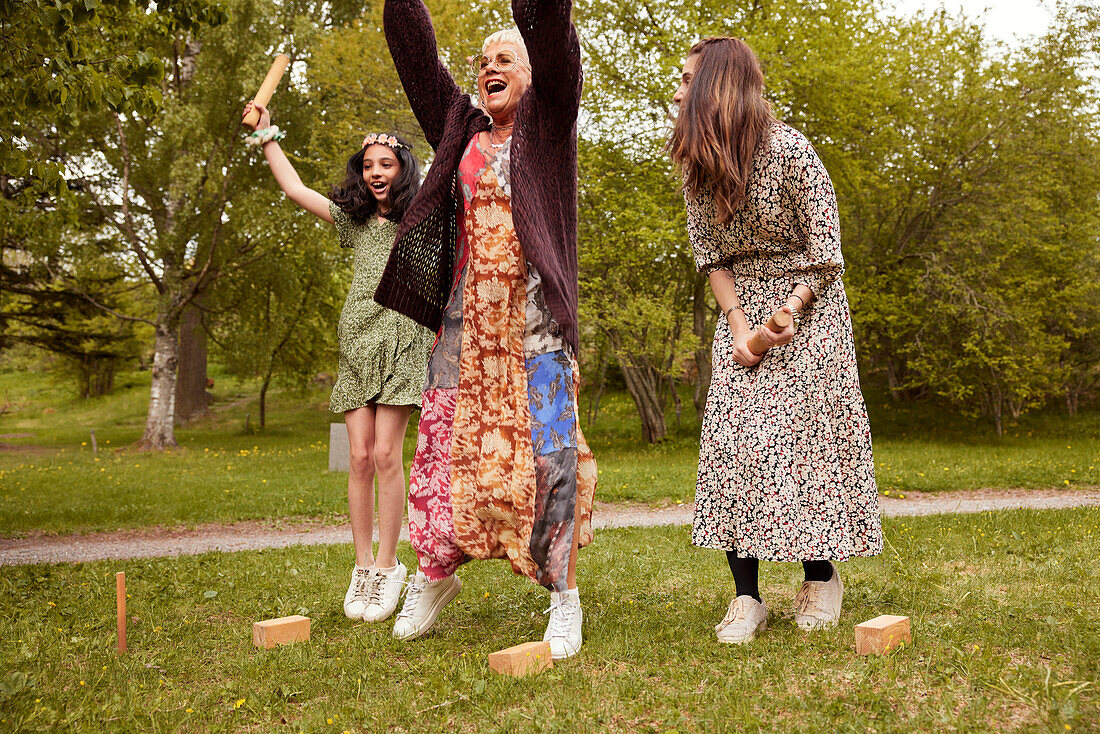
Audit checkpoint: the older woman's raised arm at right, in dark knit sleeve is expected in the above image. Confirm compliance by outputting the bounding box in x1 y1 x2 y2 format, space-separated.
512 0 581 135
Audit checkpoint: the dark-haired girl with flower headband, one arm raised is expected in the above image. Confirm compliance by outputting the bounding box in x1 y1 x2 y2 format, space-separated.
244 101 433 622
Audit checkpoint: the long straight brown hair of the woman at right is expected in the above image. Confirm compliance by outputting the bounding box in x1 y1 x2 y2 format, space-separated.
668 37 776 223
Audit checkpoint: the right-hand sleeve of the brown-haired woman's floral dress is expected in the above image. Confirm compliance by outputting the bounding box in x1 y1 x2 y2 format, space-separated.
787 134 844 295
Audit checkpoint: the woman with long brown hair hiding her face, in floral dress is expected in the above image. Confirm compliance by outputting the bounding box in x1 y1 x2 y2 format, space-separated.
669 37 882 643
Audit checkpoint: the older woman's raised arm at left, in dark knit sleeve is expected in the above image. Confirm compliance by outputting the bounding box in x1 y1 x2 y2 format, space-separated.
382 0 462 149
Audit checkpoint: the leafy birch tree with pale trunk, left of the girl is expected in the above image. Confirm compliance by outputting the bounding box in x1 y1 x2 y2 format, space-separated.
27 0 336 448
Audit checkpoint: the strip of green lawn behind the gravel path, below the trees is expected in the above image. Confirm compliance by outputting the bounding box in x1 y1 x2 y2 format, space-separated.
0 372 1100 536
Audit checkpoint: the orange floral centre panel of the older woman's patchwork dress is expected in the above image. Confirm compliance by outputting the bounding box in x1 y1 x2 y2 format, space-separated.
451 167 538 579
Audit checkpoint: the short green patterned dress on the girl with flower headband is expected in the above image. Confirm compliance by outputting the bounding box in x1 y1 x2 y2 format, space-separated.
329 201 435 413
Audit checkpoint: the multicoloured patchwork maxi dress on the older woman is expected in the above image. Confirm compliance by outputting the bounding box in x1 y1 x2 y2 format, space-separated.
409 135 596 591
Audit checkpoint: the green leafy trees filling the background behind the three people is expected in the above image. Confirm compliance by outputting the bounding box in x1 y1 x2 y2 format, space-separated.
0 0 1100 446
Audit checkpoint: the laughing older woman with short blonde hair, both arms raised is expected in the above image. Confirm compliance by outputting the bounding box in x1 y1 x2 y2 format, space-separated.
375 0 596 659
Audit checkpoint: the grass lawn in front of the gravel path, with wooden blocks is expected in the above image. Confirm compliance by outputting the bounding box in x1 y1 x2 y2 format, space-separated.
0 510 1100 733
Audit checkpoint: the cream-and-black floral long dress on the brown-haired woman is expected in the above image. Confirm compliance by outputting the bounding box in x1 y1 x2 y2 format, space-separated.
688 123 882 561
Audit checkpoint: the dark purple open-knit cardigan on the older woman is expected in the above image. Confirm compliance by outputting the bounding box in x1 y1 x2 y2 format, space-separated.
374 0 581 353
